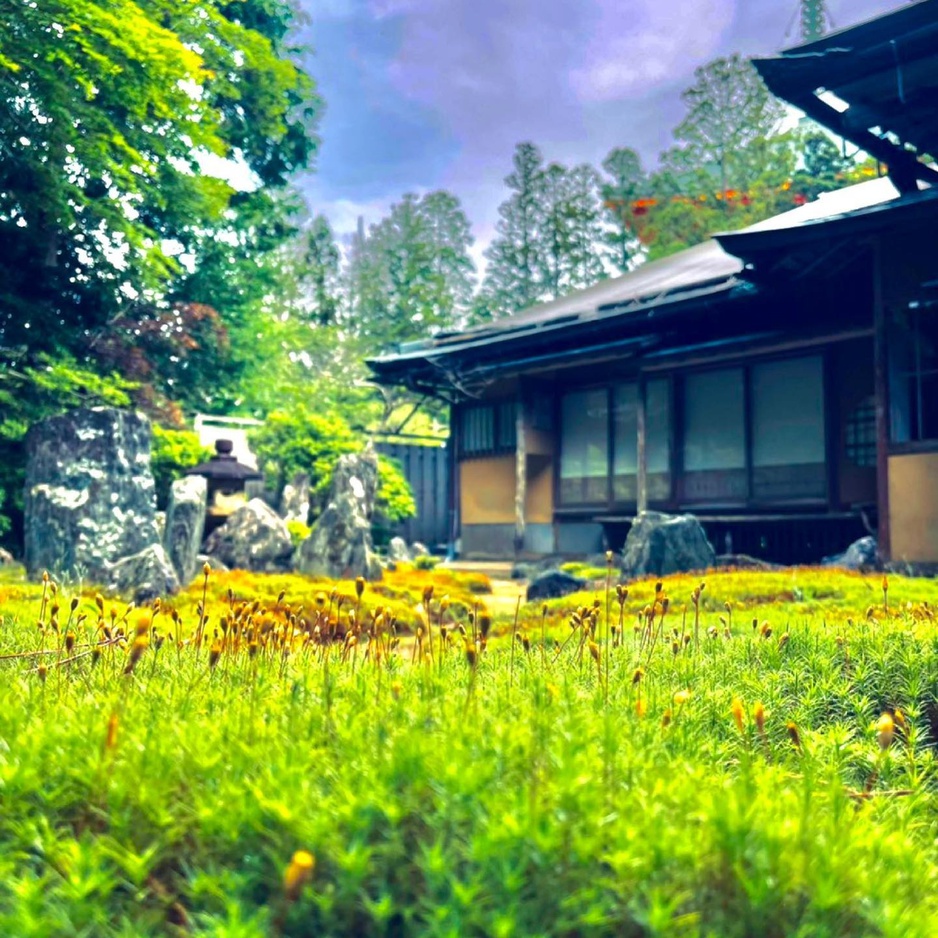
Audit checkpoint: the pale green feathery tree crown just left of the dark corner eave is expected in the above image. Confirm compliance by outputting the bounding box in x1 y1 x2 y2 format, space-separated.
662 55 784 210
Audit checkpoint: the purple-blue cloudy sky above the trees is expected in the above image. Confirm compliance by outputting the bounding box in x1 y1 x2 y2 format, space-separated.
301 0 903 252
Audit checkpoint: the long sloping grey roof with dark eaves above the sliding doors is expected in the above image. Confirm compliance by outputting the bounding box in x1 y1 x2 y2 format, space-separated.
368 177 938 393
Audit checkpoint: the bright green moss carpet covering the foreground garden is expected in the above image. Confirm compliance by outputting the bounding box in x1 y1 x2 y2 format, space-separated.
0 569 938 938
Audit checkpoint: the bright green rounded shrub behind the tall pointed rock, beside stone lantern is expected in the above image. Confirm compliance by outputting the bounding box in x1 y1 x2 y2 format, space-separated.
250 405 416 526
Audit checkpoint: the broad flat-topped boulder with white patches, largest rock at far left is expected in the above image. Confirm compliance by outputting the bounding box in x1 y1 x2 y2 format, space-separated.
24 407 160 583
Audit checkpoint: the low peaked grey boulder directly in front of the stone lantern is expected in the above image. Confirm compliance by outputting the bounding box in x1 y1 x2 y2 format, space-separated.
205 498 293 573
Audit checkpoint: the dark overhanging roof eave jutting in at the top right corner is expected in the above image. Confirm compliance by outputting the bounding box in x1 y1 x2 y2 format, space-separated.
753 0 938 192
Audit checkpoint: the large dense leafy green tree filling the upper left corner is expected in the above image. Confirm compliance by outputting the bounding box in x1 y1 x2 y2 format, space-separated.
0 0 315 355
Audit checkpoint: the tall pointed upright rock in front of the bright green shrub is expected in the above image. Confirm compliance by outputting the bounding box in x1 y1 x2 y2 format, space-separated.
294 448 381 580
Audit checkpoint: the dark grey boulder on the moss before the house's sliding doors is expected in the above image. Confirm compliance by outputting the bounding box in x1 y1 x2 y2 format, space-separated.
622 511 716 579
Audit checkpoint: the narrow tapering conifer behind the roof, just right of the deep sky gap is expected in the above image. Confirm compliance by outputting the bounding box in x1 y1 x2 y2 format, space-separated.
482 143 544 317
